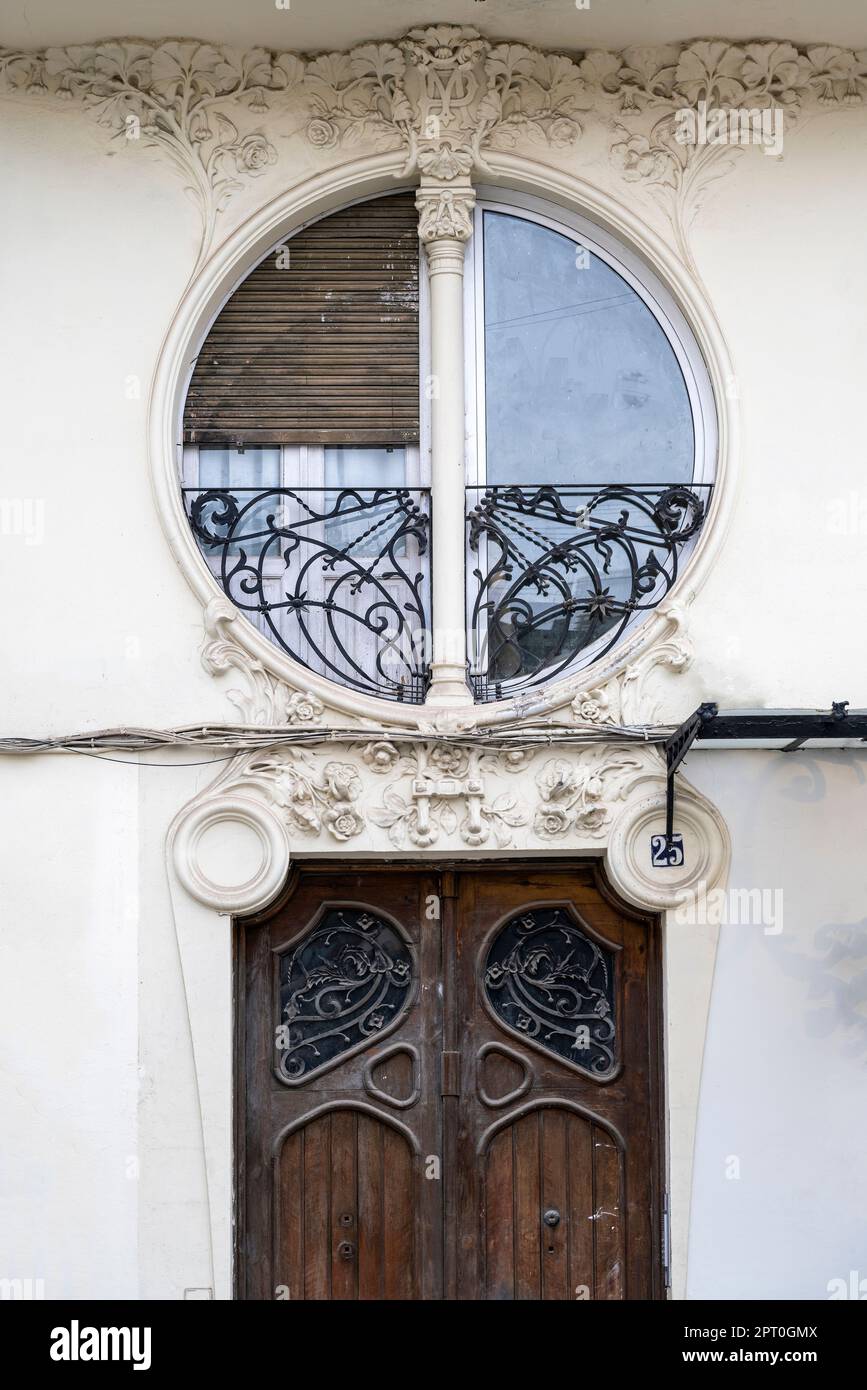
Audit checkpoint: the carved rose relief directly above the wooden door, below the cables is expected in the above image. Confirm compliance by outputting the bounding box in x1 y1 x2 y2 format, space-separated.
200 739 660 853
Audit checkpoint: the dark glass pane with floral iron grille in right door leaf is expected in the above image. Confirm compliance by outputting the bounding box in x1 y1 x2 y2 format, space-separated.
485 908 617 1076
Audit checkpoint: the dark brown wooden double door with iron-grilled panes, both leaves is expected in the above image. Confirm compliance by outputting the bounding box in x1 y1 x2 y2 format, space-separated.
236 865 664 1300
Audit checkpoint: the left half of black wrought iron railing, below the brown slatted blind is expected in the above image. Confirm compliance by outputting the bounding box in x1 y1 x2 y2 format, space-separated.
185 488 429 703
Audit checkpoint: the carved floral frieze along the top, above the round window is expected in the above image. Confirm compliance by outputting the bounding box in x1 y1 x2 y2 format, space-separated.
0 24 867 268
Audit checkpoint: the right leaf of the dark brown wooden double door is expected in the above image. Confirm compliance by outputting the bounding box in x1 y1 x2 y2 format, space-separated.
456 866 661 1300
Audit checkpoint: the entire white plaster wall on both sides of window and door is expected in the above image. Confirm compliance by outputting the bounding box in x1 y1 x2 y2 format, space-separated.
0 24 867 1298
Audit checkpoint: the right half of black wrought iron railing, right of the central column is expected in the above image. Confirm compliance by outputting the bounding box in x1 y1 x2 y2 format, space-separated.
468 484 710 701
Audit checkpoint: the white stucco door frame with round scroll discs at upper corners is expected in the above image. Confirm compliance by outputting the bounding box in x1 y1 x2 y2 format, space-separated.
167 795 731 1298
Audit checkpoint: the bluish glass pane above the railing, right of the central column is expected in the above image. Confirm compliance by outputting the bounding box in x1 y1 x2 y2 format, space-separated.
484 211 695 485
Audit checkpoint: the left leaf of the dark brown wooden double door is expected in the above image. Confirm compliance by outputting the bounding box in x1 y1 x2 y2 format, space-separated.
239 869 442 1300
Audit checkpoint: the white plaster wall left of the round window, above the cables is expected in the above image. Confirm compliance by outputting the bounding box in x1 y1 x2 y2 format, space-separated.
0 100 226 739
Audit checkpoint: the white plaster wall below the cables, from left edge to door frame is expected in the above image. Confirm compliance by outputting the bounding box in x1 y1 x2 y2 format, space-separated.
0 753 231 1298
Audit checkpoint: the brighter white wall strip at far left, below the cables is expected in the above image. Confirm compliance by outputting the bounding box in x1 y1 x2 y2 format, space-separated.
0 756 140 1298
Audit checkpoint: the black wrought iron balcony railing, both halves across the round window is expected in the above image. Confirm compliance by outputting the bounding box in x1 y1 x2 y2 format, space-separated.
183 484 711 703
